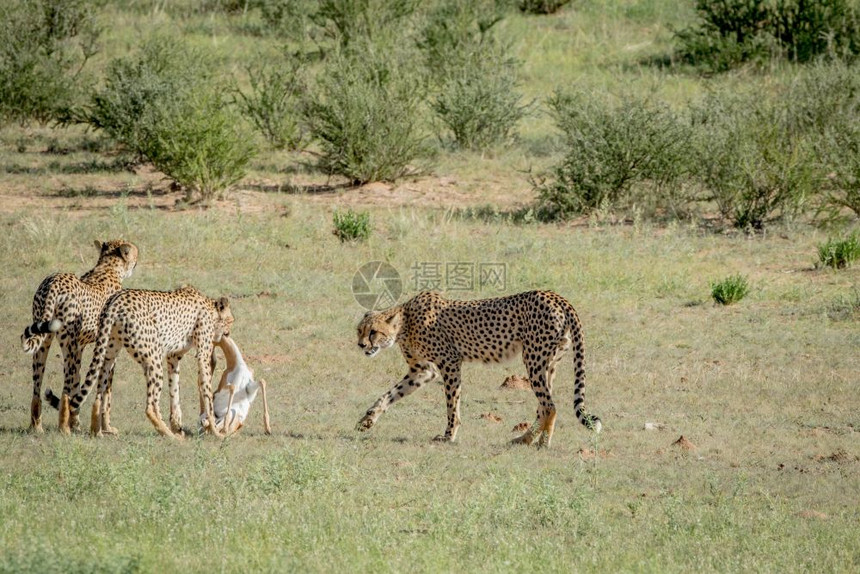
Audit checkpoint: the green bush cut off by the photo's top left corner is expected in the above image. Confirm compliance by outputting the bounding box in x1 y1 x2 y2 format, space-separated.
0 0 99 124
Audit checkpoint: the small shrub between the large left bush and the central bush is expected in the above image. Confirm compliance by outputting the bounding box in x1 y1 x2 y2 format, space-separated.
234 60 306 150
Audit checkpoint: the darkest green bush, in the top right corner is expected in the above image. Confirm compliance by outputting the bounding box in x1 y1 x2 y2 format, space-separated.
675 0 860 72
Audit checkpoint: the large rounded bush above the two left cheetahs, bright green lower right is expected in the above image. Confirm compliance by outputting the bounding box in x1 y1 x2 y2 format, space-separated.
77 38 254 199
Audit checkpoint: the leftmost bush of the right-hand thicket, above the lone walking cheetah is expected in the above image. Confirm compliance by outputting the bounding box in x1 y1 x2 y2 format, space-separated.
533 92 691 220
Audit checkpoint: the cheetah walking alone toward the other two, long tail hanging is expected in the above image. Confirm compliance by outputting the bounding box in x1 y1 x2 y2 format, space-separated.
356 291 601 447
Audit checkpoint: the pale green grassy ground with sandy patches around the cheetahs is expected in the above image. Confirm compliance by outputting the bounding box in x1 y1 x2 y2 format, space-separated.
0 0 860 573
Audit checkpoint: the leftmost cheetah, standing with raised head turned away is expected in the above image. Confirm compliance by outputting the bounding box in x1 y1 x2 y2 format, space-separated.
21 239 137 433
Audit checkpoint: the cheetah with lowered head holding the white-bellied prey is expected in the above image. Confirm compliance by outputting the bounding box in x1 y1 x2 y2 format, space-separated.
60 286 233 438
